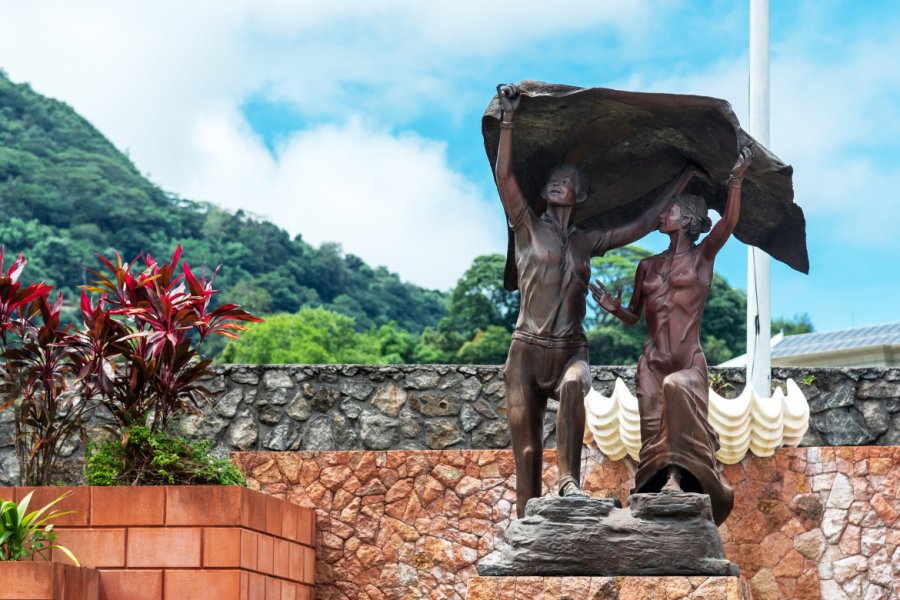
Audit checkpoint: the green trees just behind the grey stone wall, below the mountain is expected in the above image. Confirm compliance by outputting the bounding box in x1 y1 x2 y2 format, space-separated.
222 247 745 364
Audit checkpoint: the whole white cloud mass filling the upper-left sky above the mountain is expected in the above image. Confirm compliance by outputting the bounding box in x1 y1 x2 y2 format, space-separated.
0 0 666 288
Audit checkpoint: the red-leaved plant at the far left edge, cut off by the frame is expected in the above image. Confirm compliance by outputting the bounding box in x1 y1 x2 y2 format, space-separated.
0 248 90 485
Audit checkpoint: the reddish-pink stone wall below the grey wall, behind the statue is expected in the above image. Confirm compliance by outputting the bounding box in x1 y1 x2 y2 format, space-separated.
239 447 900 600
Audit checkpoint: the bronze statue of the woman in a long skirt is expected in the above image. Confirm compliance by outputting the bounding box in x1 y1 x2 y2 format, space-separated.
591 146 752 524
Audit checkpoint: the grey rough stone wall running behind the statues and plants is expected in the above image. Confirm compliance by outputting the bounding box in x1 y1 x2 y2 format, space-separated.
0 365 900 485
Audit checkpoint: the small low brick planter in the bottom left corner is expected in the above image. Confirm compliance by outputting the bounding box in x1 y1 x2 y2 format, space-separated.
0 561 100 600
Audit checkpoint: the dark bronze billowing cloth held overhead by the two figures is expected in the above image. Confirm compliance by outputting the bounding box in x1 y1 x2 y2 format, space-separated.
482 81 809 289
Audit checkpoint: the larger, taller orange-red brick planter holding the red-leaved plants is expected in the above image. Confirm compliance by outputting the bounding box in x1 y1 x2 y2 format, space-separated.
0 486 315 600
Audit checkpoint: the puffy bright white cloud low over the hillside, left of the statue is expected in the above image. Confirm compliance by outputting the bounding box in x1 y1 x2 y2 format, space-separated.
184 113 504 289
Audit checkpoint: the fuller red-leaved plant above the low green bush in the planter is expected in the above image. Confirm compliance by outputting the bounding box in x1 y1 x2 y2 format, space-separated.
74 246 261 434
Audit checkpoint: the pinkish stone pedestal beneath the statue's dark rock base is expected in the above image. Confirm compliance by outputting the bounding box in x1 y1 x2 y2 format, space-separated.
466 576 751 600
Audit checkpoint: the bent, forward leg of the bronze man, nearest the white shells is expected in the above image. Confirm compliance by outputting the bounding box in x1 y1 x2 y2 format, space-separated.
556 357 591 493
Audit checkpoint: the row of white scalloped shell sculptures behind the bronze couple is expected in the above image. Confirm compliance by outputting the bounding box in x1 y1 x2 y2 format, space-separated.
585 378 809 464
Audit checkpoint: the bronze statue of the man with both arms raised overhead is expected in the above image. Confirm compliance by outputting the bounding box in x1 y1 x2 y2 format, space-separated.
495 84 696 518
